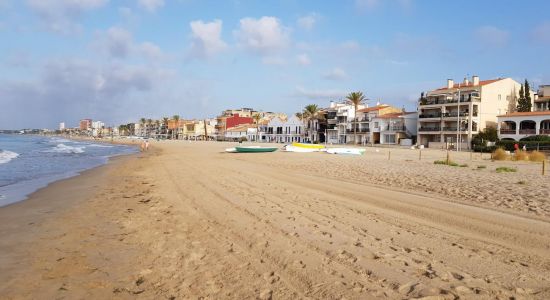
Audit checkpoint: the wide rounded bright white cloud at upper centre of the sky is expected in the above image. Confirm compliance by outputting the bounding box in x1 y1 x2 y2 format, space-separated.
235 17 290 54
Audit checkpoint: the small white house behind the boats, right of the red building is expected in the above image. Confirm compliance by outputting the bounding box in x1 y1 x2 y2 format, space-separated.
265 116 305 143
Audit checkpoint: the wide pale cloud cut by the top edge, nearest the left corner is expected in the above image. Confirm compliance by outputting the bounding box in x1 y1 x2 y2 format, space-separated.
27 0 109 33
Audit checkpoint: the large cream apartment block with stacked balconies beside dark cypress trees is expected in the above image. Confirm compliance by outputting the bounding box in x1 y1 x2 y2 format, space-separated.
418 76 521 149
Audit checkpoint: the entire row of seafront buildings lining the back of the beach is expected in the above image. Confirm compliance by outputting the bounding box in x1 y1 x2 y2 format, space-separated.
19 76 550 150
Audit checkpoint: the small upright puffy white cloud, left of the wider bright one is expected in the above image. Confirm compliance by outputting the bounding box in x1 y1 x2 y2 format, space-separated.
189 20 227 58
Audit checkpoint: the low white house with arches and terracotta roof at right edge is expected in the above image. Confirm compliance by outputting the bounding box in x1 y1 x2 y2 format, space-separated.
497 110 550 141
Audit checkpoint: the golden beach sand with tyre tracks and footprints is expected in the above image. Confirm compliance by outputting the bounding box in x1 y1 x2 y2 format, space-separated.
0 141 550 299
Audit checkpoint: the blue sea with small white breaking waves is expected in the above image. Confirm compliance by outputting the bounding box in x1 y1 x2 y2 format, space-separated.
0 134 138 207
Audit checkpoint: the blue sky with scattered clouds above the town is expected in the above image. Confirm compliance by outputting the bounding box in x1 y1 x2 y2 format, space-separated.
0 0 550 129
